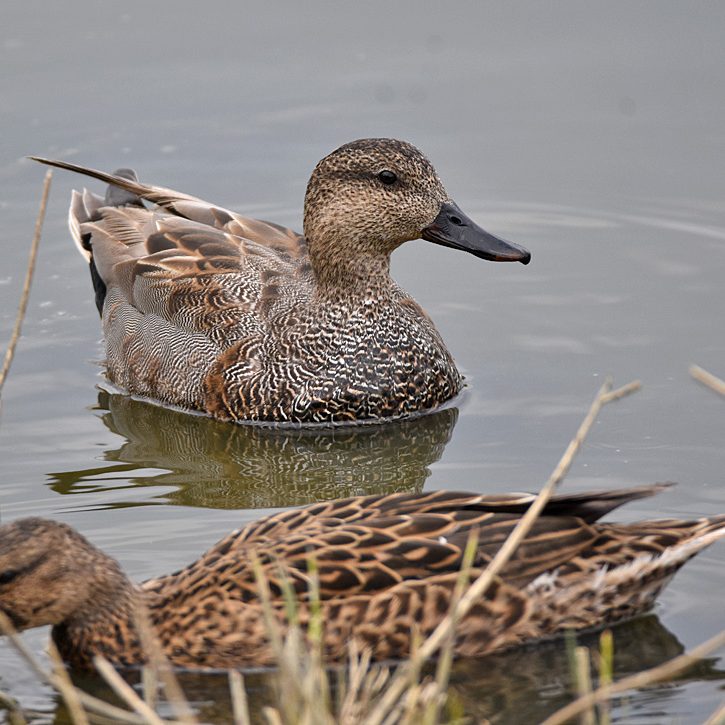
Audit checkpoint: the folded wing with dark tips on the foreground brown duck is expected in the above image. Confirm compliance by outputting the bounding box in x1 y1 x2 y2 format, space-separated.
144 485 662 602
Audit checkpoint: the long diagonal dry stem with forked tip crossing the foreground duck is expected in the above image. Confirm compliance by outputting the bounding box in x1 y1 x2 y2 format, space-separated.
367 378 640 725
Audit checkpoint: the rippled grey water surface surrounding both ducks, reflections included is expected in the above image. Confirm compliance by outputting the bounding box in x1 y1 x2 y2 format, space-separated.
0 1 725 723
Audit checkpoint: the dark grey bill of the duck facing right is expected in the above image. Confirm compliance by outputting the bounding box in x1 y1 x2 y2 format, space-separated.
420 201 531 264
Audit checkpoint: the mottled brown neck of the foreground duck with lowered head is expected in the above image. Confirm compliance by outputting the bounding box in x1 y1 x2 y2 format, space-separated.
52 557 145 668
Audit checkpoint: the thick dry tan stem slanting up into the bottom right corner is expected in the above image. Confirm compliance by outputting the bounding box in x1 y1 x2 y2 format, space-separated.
541 629 725 725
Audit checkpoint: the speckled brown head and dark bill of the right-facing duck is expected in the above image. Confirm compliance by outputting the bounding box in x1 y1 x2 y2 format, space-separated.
304 138 531 288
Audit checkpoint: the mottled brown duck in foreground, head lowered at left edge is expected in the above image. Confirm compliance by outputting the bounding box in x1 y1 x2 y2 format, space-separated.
0 484 725 668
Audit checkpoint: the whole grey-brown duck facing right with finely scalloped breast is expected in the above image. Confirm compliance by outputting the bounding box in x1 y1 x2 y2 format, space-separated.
33 139 531 424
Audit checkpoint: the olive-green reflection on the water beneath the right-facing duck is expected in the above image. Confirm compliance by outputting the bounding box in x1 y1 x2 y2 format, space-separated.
50 390 458 509
